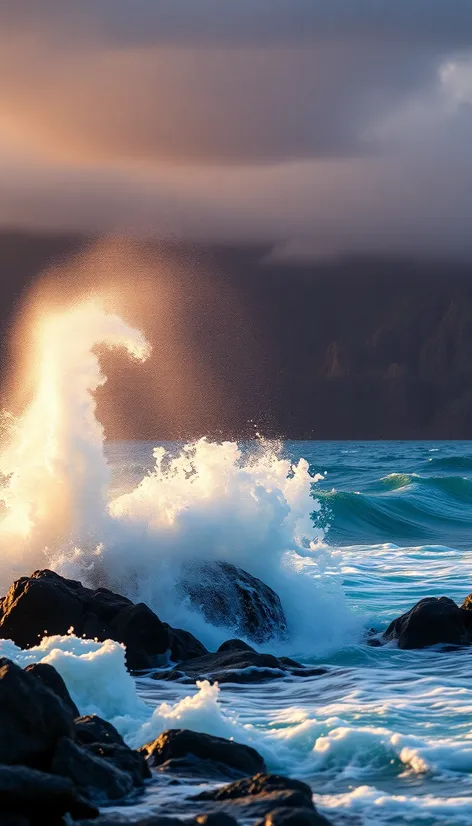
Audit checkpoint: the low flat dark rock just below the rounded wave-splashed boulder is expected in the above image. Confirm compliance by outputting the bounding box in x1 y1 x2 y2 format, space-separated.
152 648 326 683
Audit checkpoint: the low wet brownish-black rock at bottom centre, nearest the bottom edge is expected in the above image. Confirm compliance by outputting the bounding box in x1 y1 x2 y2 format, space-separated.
192 774 314 818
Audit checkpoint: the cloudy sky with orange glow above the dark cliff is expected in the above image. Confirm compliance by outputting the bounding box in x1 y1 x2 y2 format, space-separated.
0 0 472 257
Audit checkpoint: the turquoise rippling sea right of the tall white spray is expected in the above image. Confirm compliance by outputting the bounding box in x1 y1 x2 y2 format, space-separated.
104 442 472 826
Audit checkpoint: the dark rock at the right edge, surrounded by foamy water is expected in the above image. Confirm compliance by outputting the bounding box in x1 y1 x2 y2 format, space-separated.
384 597 472 648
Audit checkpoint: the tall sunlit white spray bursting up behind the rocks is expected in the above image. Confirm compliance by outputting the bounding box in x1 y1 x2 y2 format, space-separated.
0 303 357 651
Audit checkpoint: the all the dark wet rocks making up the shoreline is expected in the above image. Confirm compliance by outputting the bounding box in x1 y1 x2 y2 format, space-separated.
0 563 472 826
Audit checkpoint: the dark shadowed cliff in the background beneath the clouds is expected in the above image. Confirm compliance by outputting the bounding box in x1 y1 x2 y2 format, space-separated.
0 233 472 439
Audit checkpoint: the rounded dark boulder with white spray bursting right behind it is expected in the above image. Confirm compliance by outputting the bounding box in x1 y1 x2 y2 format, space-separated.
180 561 287 643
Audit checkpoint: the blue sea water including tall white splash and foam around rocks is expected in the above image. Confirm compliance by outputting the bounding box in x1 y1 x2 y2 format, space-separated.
0 304 472 826
